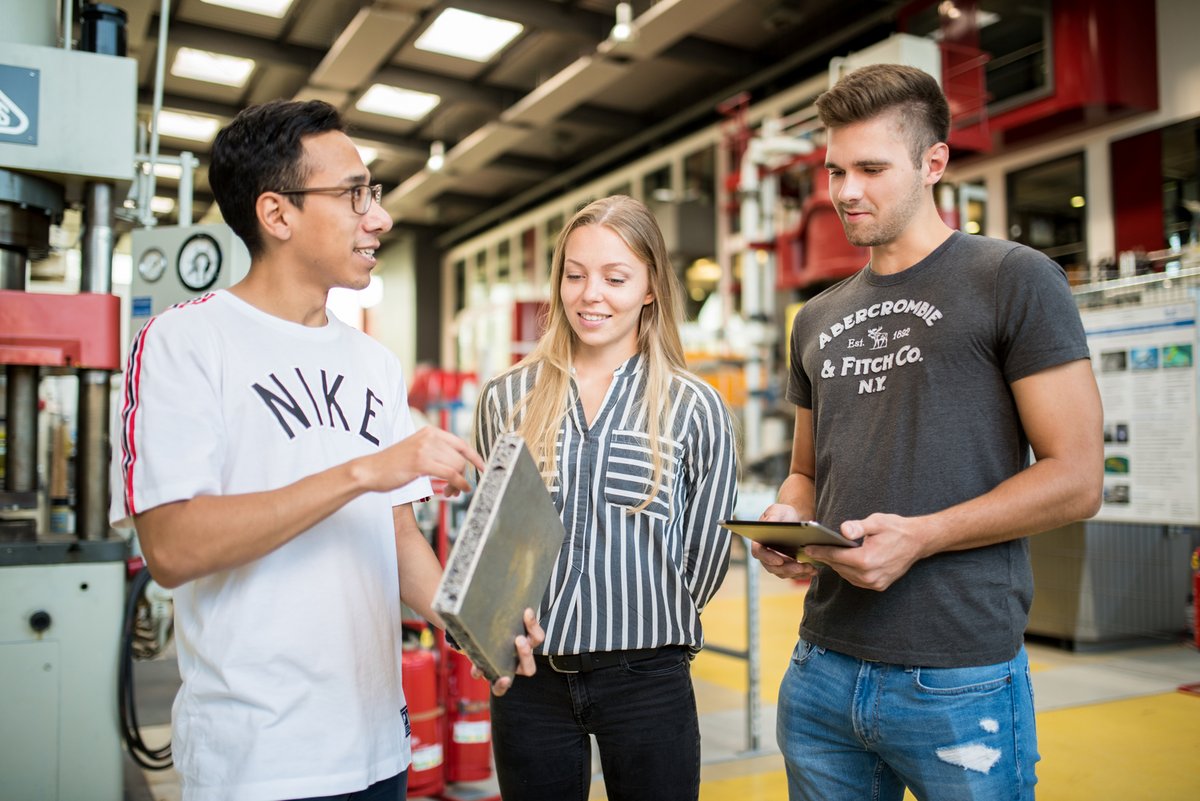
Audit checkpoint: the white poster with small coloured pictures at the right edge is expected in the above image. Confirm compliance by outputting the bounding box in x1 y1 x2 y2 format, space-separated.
1082 297 1200 525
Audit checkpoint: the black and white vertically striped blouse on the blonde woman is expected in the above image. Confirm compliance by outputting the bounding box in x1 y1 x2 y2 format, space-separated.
475 355 737 655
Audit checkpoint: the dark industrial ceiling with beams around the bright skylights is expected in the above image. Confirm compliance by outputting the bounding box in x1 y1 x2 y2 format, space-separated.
112 0 899 243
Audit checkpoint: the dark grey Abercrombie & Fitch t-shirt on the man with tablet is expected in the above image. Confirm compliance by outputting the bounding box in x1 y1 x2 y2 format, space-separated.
787 233 1088 667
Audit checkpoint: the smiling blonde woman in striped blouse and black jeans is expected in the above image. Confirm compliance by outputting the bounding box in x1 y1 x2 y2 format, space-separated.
476 195 737 801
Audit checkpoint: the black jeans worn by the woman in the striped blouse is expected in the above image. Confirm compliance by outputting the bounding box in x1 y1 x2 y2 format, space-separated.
492 648 700 801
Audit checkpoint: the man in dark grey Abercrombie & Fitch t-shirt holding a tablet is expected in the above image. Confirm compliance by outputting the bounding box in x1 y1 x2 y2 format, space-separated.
752 65 1103 801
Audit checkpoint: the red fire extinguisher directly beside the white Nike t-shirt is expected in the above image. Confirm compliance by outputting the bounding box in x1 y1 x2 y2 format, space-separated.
401 637 445 797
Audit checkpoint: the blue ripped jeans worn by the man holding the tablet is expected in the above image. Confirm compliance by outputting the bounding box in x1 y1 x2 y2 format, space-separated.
775 639 1038 801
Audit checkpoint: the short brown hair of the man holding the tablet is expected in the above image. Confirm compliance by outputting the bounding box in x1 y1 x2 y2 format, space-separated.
817 64 950 164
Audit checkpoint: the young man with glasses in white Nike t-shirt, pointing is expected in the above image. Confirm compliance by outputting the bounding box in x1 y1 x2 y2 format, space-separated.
114 101 541 801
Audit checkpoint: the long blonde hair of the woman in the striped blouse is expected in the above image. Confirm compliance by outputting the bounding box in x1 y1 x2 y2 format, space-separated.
509 194 686 511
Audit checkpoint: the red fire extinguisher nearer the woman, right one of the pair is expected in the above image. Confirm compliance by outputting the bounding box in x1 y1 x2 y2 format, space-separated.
446 650 492 782
